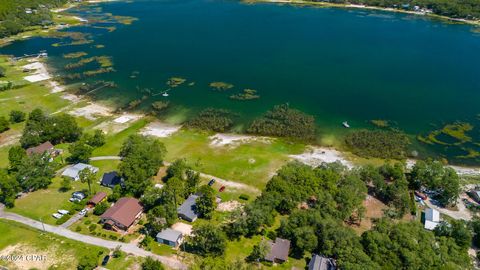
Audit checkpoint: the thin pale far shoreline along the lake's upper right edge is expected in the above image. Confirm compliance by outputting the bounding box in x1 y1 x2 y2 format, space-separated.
241 0 480 26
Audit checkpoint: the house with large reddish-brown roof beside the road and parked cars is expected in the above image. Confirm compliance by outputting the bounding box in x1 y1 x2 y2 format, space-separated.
100 197 143 231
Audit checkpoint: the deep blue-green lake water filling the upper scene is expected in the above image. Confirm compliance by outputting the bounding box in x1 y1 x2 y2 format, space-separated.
0 0 480 163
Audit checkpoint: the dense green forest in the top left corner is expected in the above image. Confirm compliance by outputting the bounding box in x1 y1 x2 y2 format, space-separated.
0 0 67 38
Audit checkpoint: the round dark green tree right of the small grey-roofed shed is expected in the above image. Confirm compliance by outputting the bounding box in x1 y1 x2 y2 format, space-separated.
187 223 227 256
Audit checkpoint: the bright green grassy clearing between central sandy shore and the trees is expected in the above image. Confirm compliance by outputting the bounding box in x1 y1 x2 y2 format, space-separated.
160 130 305 188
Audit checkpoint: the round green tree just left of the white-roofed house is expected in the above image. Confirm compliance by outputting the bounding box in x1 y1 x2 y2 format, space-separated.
16 154 55 191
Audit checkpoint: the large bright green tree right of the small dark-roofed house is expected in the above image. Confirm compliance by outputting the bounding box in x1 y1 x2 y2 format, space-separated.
119 135 166 197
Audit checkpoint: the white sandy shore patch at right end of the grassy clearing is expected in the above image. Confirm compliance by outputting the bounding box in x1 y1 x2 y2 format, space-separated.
290 146 353 168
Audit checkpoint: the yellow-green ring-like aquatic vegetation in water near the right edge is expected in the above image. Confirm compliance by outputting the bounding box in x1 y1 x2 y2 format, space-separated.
417 122 473 145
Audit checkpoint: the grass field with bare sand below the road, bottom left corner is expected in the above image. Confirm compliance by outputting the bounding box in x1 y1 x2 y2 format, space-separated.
0 220 141 270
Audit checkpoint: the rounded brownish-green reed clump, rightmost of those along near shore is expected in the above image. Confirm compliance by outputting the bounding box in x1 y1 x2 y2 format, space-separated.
345 130 410 159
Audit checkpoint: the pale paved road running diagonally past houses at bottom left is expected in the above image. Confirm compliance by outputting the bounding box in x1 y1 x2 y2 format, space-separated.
0 204 187 270
